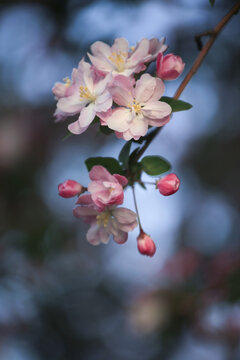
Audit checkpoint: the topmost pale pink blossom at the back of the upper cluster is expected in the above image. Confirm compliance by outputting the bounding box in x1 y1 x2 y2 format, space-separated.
88 38 167 77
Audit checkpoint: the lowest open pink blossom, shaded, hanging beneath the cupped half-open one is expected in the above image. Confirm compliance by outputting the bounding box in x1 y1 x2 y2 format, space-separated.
73 194 137 245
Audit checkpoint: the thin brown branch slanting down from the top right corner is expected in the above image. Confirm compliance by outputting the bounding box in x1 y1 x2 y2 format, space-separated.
136 1 240 160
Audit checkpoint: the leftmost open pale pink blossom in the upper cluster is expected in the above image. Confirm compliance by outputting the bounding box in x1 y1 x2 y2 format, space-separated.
54 59 112 134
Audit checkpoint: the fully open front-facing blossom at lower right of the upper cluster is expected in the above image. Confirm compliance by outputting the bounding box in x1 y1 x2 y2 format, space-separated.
99 74 172 141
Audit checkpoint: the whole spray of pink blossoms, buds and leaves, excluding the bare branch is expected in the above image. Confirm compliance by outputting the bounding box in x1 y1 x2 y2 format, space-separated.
52 38 188 256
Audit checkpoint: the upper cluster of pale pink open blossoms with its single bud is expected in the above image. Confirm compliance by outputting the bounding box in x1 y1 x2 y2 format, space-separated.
53 38 184 141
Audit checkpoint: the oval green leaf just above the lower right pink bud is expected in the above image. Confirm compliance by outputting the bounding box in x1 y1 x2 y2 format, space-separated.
141 155 171 176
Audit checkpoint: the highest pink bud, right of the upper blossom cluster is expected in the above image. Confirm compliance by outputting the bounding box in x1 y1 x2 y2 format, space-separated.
157 53 185 80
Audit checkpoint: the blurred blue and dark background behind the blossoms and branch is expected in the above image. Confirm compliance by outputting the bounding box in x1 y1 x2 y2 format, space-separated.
0 0 240 360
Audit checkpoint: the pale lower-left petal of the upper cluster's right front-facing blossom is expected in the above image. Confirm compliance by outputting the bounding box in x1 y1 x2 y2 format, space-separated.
106 108 132 132
